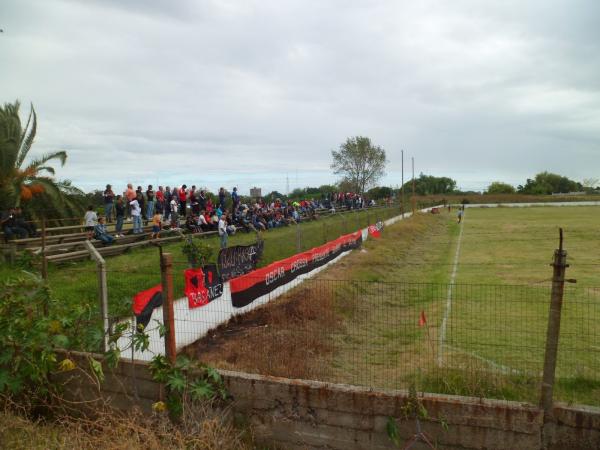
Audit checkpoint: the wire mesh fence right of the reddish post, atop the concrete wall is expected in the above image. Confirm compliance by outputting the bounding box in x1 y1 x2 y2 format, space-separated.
177 279 600 404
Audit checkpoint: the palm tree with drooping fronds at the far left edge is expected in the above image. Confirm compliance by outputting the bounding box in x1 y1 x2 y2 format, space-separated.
0 101 82 221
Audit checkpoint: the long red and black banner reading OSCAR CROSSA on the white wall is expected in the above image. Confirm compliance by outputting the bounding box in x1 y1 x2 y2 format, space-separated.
229 231 362 308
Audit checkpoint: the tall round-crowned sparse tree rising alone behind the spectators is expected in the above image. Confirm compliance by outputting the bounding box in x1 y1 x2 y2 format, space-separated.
331 136 387 194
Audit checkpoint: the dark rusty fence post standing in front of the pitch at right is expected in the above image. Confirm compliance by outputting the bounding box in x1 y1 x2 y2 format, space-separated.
540 228 569 422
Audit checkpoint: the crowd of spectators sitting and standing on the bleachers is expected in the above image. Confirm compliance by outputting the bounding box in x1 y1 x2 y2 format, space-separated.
1 184 374 244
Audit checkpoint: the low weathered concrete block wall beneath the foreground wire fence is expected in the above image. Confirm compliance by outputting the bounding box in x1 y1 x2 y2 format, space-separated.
59 352 600 450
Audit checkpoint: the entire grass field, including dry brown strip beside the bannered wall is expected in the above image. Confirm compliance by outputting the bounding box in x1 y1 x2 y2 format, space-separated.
188 207 600 405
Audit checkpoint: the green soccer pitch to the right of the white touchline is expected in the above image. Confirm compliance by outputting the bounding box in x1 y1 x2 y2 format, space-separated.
438 207 600 403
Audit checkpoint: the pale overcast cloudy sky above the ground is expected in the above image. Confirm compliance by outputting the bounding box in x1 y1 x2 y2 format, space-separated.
0 0 600 194
